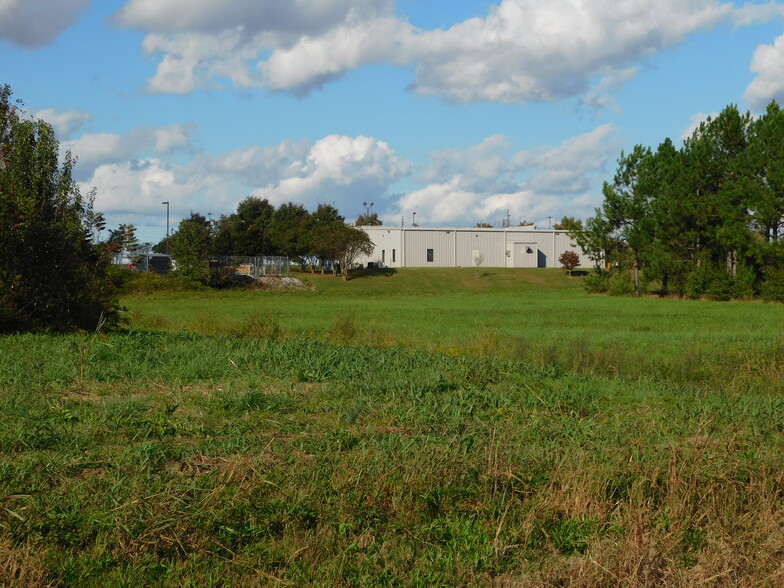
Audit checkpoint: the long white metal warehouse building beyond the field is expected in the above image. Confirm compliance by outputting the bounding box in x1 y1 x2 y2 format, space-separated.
357 226 593 267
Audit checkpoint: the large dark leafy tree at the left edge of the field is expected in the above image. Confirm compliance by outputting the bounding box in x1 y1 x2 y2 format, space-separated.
0 86 119 332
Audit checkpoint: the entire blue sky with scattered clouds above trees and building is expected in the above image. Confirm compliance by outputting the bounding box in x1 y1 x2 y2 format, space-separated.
0 0 784 243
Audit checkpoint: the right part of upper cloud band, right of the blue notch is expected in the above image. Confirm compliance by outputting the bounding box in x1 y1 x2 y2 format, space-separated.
407 0 731 103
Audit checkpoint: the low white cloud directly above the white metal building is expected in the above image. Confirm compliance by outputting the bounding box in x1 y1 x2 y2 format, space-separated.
386 125 619 226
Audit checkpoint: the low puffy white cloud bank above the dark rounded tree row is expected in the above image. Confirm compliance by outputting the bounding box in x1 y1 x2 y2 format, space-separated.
72 127 411 234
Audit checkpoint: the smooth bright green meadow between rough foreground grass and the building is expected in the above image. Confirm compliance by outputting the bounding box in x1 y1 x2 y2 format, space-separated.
123 268 784 386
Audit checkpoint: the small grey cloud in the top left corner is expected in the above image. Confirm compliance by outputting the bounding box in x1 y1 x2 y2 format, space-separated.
0 0 90 49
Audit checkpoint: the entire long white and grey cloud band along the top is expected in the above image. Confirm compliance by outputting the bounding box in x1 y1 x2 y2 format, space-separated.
115 0 784 103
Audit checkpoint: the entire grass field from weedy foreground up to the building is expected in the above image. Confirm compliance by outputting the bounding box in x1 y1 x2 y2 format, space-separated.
0 269 784 586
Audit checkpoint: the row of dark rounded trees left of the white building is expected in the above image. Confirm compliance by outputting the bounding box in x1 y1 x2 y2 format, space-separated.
153 196 380 285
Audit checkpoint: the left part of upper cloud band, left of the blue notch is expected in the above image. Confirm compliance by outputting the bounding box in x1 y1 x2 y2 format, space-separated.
114 0 403 94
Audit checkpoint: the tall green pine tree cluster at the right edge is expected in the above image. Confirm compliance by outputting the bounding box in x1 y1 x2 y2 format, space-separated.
573 102 784 300
